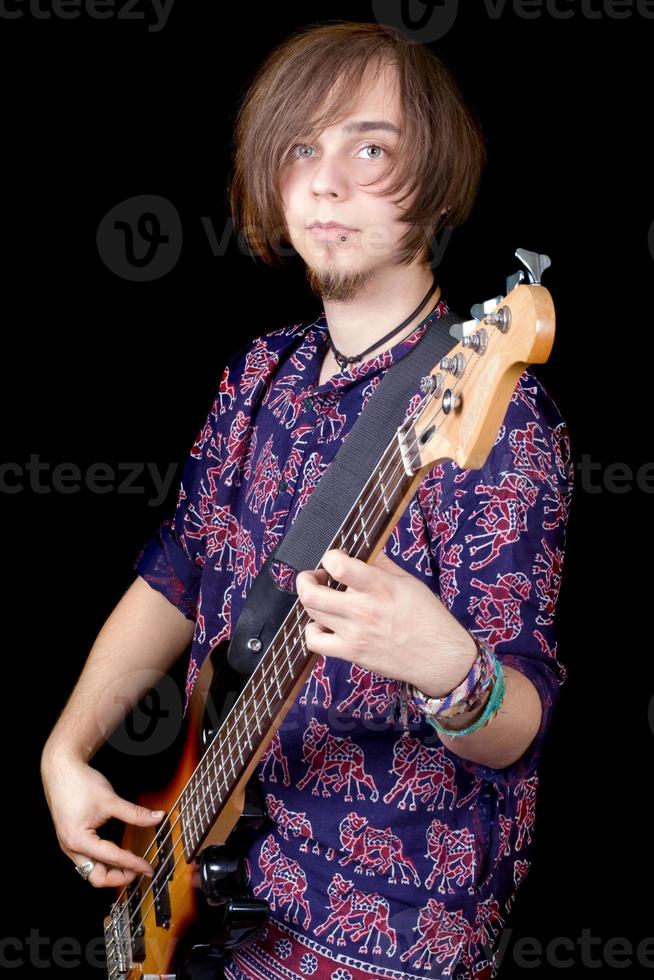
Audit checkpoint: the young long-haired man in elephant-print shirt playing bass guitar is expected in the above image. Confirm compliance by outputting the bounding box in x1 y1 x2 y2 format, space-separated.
43 23 572 980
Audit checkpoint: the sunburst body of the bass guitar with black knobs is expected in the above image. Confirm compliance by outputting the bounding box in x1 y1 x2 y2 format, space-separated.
105 644 276 980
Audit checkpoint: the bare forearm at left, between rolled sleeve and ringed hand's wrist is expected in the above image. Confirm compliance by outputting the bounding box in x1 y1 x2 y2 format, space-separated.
42 576 194 762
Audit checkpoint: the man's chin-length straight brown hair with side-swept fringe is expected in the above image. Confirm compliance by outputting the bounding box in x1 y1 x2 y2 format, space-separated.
227 20 487 265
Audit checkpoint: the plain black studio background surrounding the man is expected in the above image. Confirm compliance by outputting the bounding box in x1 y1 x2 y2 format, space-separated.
0 0 654 977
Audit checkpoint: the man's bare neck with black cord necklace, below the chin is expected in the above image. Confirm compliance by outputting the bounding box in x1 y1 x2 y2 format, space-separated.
324 265 441 360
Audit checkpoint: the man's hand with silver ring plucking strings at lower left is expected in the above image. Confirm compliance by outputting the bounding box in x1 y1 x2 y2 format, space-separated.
41 752 163 888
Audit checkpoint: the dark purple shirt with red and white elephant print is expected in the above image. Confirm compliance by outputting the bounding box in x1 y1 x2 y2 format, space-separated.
134 300 574 980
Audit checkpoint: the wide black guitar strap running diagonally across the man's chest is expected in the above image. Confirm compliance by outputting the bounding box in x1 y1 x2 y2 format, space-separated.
227 313 462 674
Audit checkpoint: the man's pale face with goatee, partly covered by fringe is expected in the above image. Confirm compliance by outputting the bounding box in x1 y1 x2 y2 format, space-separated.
280 59 416 300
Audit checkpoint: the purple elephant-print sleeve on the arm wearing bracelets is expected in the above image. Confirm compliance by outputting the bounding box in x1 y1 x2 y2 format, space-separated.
419 369 574 783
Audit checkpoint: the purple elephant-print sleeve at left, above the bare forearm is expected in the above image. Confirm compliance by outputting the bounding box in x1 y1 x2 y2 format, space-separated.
132 351 241 621
